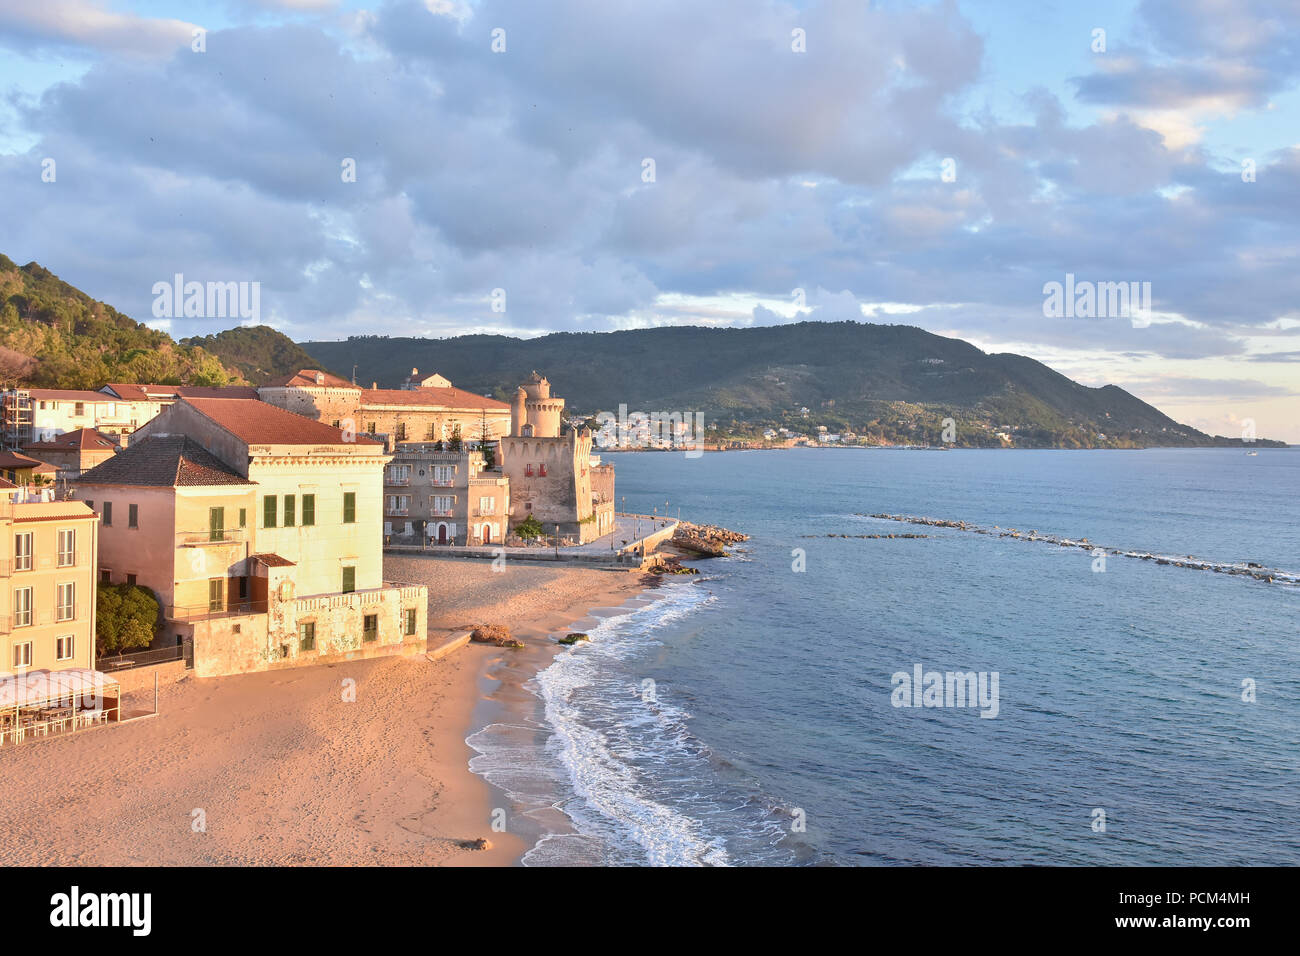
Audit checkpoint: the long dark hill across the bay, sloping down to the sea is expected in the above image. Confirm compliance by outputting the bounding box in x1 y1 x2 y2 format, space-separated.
300 321 1282 447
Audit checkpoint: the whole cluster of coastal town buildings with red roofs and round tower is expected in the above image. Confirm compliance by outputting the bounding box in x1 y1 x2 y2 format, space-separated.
0 368 736 747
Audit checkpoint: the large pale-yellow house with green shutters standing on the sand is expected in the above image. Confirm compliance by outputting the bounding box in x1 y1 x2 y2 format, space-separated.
77 399 426 676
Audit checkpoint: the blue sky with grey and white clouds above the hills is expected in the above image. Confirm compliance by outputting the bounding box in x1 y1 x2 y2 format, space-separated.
0 0 1300 442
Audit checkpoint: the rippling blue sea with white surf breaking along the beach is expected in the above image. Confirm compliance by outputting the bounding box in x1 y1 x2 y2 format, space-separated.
469 449 1300 866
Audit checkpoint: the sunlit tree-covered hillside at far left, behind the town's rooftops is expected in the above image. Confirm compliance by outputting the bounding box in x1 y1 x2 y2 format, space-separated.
0 255 242 389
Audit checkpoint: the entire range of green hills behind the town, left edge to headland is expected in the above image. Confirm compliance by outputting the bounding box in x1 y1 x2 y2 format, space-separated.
0 255 1283 447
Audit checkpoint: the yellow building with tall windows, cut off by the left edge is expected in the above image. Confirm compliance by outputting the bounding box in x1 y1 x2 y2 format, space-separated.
0 480 98 672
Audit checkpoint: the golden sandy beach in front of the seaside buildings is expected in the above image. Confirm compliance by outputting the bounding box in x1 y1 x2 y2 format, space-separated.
0 557 640 866
